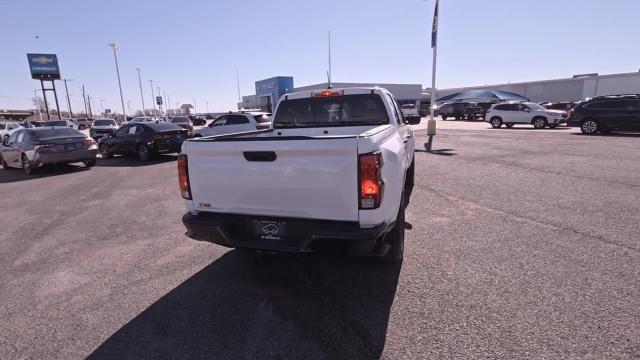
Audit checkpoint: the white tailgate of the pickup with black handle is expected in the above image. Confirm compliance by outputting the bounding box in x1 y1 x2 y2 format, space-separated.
187 137 358 221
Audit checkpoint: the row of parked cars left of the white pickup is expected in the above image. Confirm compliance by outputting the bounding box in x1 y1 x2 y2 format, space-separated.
0 111 271 174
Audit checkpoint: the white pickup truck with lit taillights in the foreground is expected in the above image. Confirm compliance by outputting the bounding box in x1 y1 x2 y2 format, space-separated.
178 87 419 261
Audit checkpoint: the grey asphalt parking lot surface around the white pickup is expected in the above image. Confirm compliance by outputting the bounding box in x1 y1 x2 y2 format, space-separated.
0 121 640 359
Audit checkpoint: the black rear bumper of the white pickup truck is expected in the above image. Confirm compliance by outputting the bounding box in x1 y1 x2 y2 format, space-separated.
182 213 391 255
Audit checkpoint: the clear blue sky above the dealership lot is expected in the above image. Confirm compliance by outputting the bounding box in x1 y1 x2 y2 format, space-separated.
0 0 640 111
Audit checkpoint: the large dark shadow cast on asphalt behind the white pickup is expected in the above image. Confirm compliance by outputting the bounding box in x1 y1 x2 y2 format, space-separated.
88 250 400 359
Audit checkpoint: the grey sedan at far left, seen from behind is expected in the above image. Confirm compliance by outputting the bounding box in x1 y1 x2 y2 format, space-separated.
0 127 98 175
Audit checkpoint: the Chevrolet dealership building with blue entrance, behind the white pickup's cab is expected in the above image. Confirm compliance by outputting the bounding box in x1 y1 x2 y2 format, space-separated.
238 76 422 112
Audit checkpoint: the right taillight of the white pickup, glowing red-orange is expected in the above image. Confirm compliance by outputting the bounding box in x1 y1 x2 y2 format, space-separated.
358 153 384 209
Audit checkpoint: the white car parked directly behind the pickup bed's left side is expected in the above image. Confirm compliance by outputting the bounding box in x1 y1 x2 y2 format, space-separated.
193 112 271 137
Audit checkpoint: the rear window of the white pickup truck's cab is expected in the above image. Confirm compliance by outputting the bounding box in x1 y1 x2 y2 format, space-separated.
273 94 389 129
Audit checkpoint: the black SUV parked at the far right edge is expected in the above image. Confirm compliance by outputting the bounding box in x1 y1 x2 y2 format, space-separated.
568 95 640 135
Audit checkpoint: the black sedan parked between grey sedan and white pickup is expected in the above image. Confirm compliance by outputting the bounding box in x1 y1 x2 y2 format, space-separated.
99 122 187 161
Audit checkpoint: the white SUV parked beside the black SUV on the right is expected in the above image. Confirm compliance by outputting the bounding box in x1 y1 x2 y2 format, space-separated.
485 102 567 129
